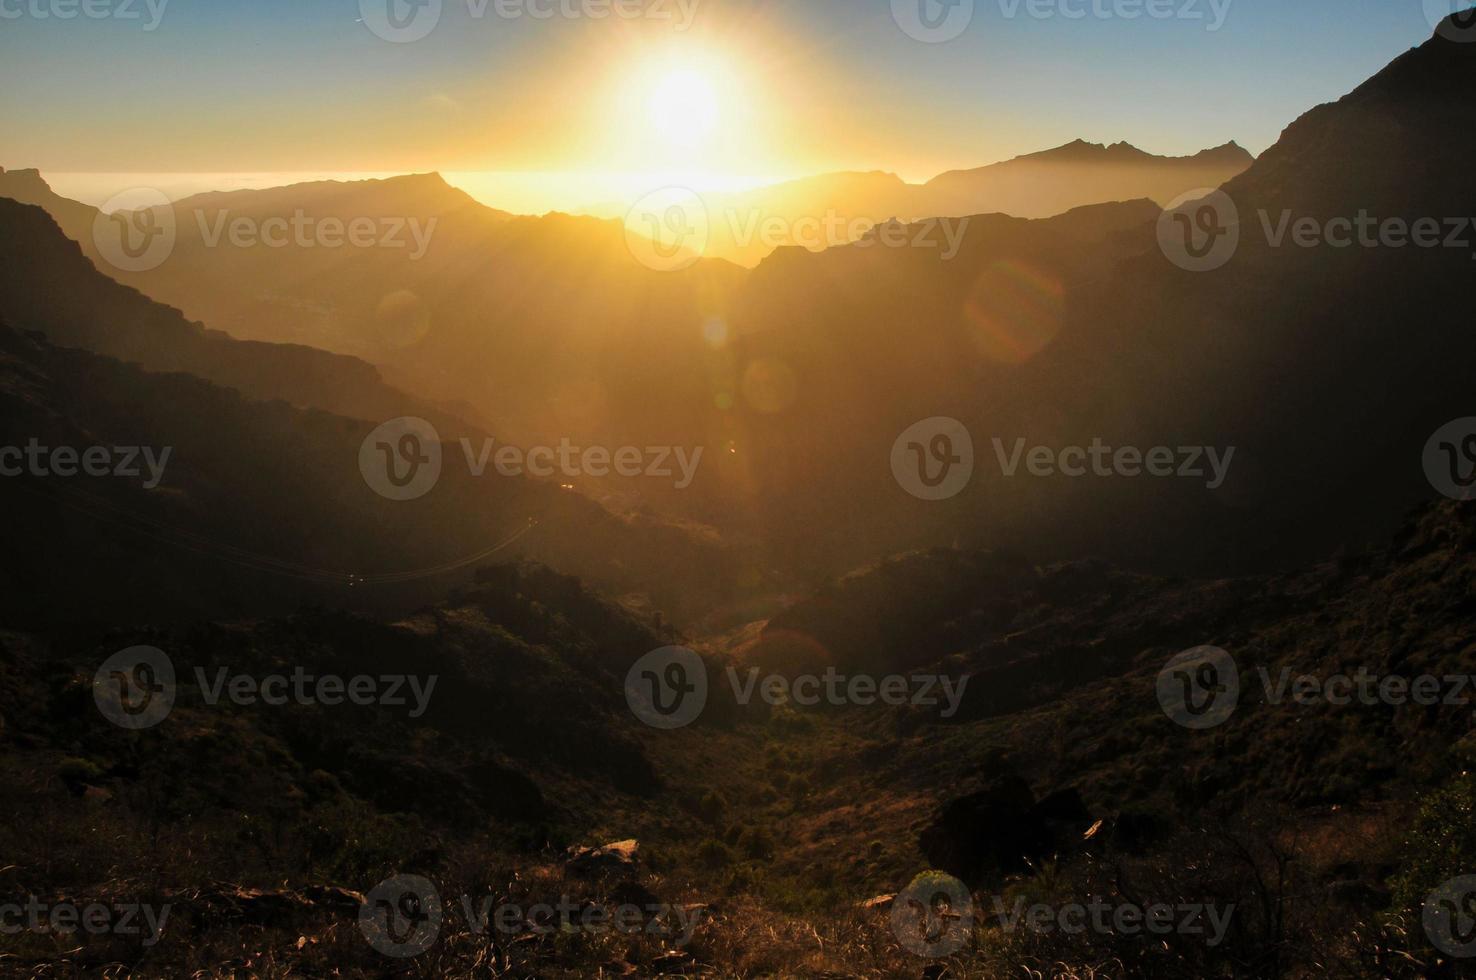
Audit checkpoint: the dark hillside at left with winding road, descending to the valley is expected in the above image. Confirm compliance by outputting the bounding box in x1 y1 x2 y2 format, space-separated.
0 321 734 626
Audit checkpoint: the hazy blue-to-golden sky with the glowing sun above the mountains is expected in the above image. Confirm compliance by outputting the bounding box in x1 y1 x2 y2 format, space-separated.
0 0 1464 197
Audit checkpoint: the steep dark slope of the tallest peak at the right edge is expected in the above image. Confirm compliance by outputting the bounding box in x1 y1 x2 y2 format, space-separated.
986 11 1476 567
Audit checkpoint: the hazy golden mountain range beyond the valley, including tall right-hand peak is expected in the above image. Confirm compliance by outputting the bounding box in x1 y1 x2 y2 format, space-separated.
0 24 1476 596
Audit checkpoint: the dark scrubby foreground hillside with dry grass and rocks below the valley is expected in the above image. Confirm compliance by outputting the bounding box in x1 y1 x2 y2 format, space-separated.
0 503 1476 980
